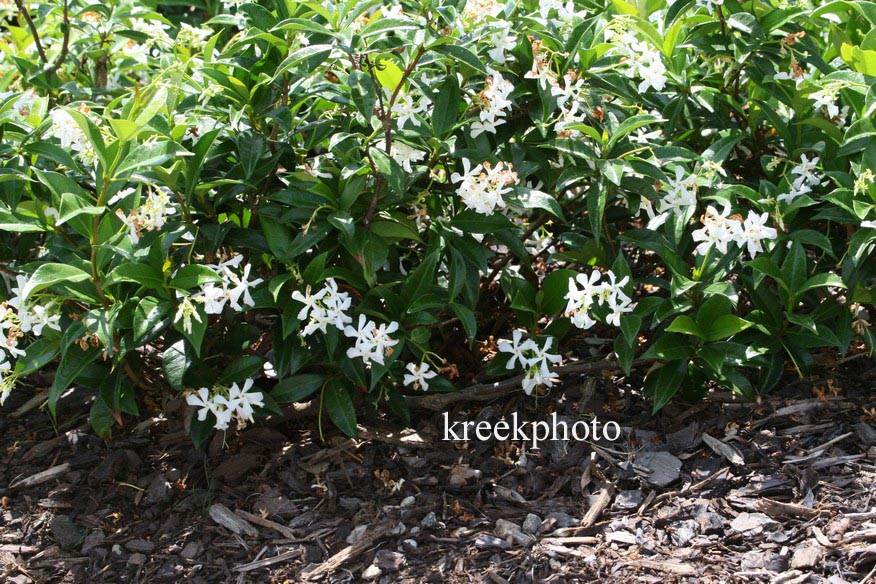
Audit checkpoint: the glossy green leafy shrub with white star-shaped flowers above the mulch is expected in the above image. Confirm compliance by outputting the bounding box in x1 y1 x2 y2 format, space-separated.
0 0 876 442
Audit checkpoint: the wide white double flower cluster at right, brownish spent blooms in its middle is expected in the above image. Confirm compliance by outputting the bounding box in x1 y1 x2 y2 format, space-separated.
693 204 778 258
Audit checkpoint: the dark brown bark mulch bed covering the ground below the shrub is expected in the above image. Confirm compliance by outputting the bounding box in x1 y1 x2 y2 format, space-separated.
0 360 876 584
